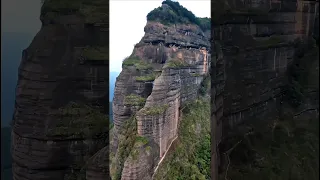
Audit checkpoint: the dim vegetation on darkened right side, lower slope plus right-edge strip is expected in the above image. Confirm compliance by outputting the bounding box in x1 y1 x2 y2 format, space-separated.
220 39 319 180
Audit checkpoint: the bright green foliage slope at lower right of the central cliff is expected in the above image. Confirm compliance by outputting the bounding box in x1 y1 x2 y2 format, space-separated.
155 99 211 180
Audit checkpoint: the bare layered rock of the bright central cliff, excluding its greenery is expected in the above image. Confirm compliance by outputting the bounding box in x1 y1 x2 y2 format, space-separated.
111 8 211 177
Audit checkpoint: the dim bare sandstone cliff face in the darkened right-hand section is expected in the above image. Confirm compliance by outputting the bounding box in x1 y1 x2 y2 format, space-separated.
214 0 318 131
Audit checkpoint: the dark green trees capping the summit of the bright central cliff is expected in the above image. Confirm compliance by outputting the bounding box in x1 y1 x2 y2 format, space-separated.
147 0 211 31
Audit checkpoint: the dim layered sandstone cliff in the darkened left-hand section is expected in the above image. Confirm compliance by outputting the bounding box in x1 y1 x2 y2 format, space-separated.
12 0 109 180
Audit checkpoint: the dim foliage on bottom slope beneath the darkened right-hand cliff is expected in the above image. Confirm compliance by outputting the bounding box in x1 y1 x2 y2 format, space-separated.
221 117 319 180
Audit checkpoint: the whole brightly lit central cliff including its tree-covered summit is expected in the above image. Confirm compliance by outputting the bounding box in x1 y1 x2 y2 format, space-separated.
110 1 211 180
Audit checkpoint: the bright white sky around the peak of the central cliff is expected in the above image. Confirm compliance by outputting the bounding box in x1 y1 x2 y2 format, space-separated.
109 0 211 72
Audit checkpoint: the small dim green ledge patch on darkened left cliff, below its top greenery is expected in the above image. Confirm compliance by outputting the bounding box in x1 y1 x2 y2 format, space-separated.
83 47 109 61
